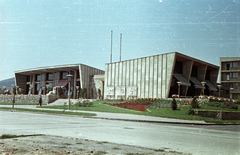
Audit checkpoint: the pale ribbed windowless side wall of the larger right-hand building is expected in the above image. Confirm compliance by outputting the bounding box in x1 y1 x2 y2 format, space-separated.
105 53 176 99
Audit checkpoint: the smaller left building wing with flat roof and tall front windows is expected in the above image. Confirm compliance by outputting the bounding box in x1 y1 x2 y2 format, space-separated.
15 64 104 98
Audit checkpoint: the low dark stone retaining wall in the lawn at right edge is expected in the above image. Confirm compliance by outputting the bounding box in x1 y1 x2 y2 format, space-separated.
194 110 240 120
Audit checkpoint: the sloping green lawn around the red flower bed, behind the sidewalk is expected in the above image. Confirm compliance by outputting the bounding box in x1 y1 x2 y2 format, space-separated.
41 101 240 123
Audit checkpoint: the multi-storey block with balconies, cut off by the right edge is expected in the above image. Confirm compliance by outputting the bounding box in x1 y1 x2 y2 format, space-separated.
220 57 240 99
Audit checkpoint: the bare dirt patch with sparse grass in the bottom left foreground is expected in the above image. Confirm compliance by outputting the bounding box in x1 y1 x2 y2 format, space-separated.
0 135 182 155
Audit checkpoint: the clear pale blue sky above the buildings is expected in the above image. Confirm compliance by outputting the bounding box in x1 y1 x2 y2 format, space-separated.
0 0 240 80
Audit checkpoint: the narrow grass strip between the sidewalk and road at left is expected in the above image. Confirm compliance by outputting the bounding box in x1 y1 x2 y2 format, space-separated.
0 107 96 116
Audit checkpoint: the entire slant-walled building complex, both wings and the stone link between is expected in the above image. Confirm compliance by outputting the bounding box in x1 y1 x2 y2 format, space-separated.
15 52 222 99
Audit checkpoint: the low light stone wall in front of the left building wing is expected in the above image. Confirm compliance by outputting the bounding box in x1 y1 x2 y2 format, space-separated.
0 94 58 104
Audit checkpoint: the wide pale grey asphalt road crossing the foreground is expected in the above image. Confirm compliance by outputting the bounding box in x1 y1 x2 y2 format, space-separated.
0 111 240 155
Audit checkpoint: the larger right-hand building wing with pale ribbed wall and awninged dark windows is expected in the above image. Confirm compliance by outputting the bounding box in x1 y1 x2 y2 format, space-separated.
104 52 219 99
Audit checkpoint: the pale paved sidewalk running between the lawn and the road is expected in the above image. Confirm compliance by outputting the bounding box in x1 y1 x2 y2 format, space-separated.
0 105 210 125
